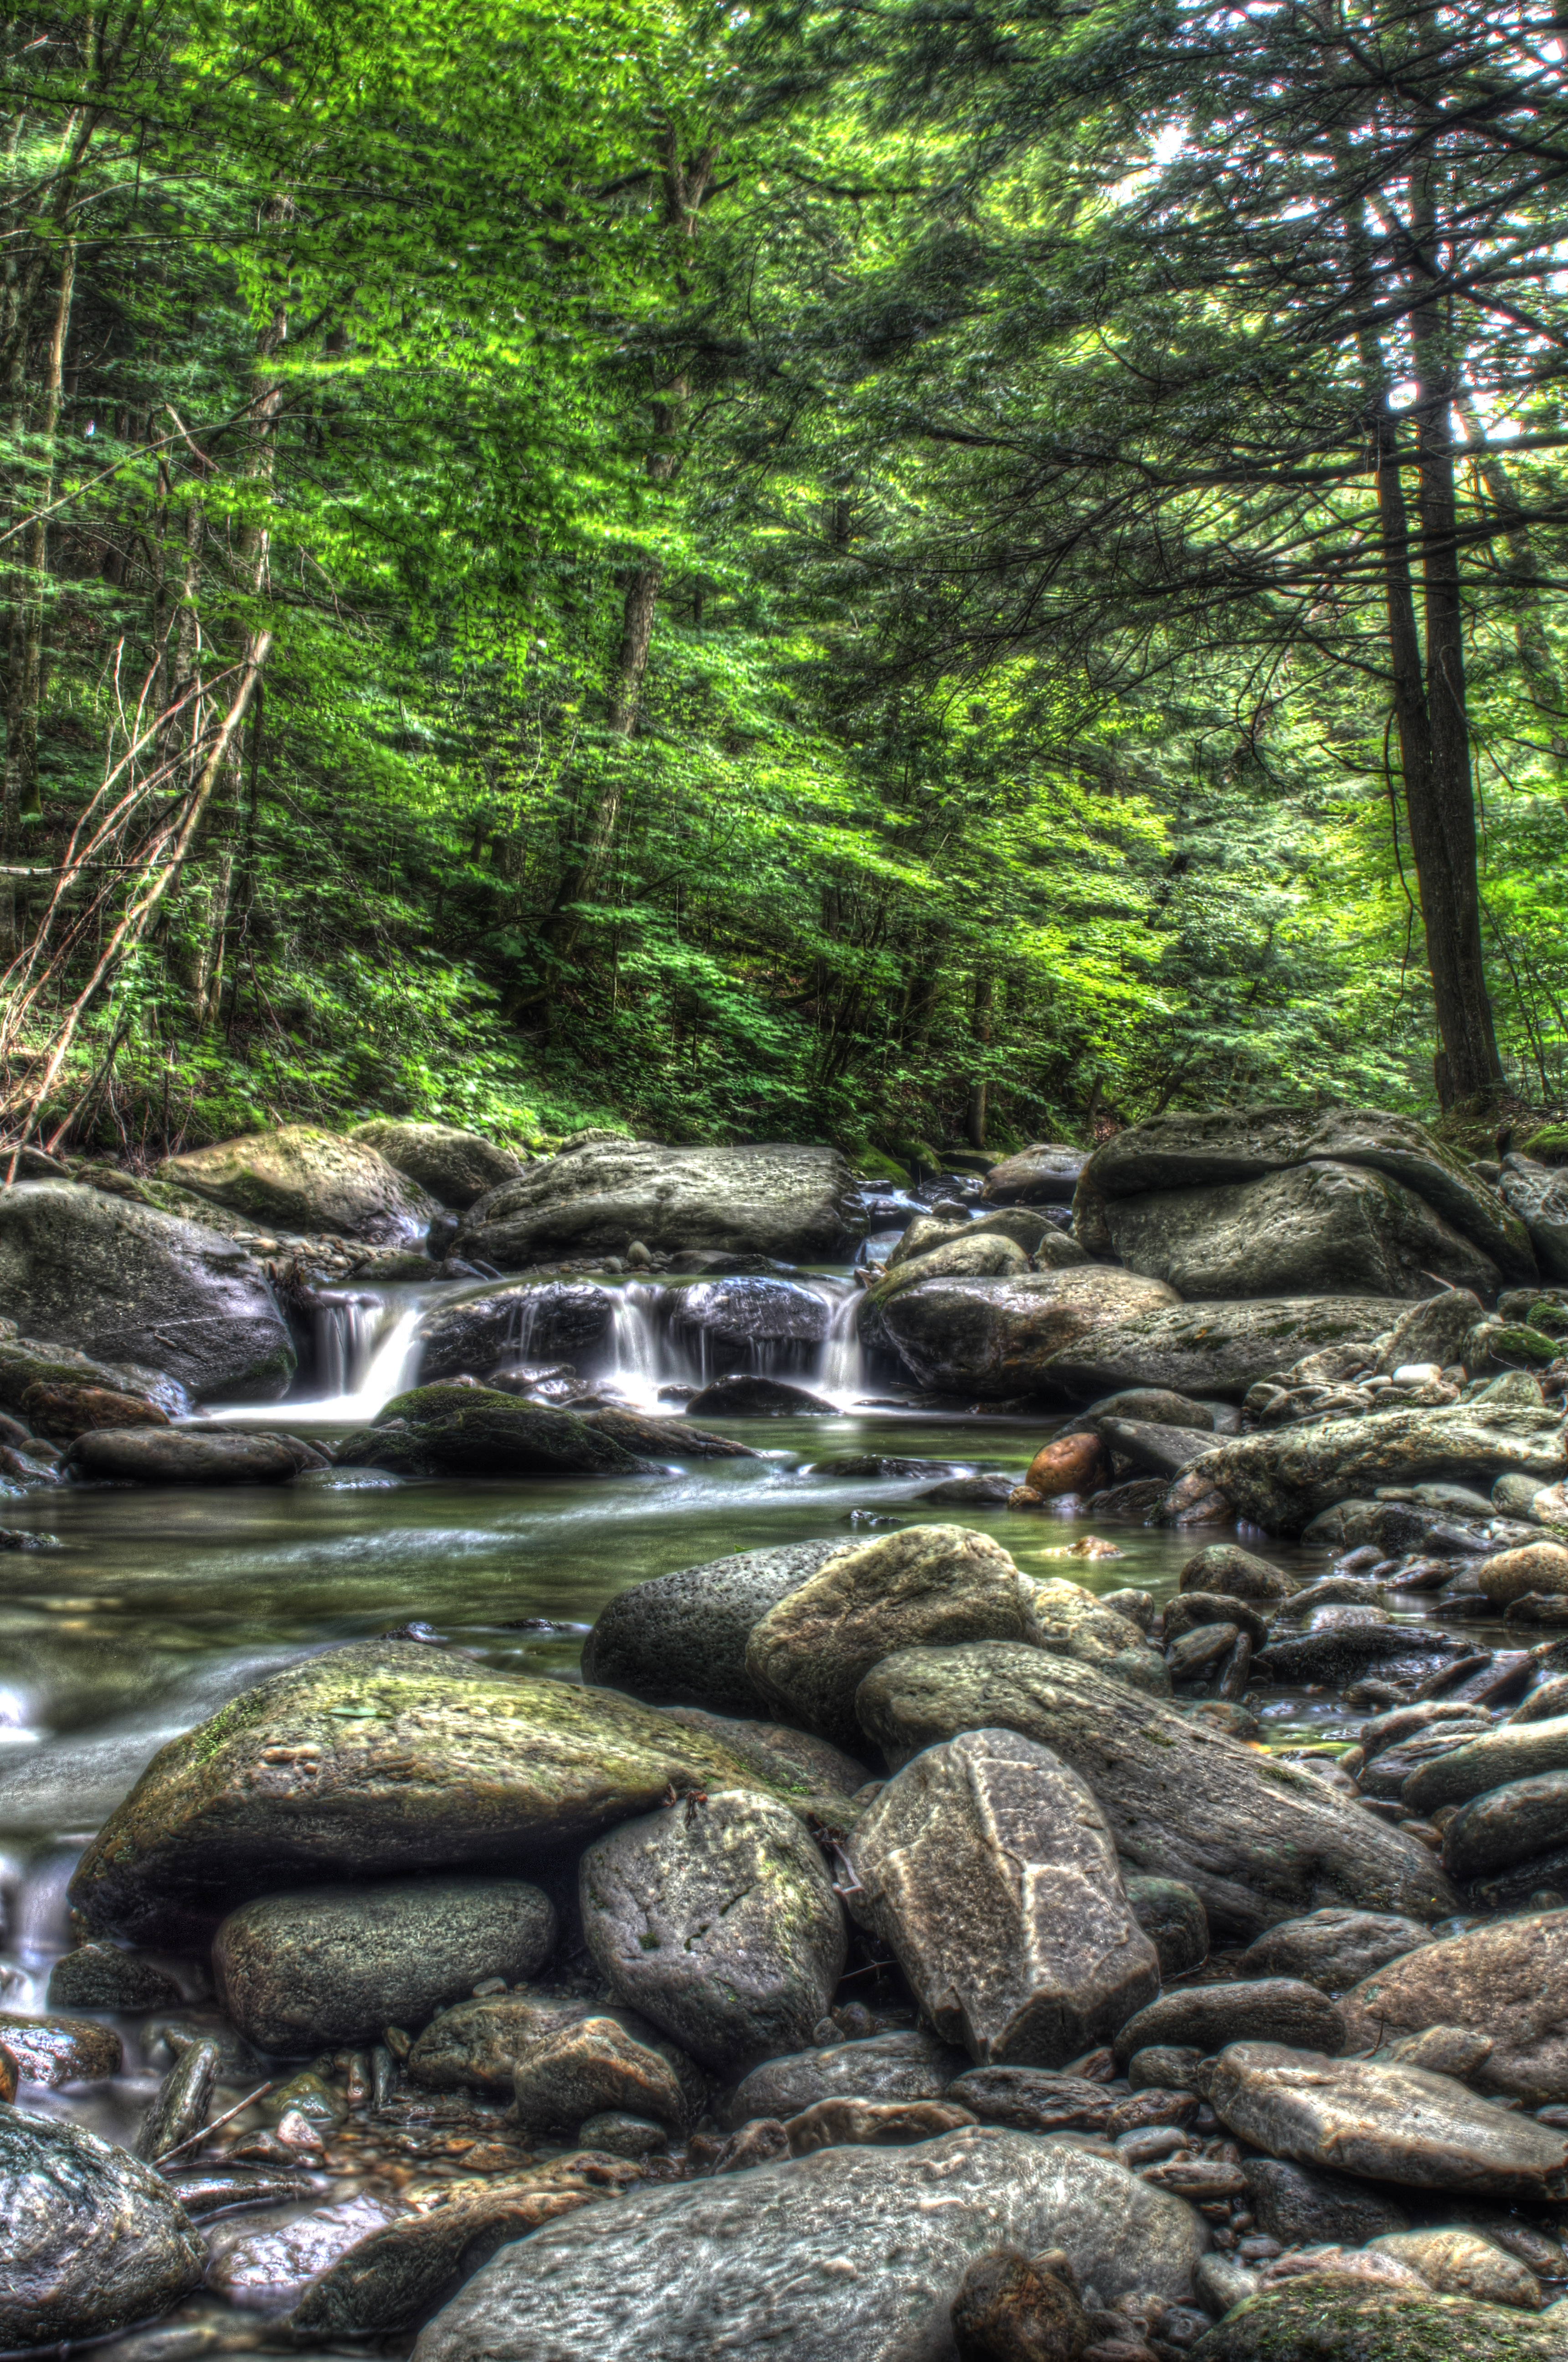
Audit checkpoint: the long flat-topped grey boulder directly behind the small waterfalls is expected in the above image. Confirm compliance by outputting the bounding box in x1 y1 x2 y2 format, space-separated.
456 1141 855 1271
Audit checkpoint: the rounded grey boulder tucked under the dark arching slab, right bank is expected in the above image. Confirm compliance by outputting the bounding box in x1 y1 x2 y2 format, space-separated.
1105 1162 1500 1301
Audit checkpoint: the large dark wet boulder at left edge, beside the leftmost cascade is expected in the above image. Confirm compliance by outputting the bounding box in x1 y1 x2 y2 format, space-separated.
0 1181 295 1403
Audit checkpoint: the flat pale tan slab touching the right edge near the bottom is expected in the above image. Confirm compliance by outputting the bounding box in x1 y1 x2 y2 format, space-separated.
1202 2041 1568 2204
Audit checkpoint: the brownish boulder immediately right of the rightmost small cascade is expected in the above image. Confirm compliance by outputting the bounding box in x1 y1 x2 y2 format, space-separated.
859 1264 1176 1401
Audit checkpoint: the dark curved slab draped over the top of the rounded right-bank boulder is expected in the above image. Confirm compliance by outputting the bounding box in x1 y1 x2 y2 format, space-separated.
1084 1108 1535 1280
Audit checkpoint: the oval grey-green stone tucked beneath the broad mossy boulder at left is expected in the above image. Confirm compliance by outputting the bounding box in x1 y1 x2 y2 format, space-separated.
212 1878 555 2058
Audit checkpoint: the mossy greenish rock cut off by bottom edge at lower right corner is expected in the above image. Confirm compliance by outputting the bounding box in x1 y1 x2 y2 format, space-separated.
1193 2274 1568 2362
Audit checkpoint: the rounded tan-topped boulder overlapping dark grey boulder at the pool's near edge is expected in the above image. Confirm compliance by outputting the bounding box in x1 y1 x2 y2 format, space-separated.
746 1526 1034 1748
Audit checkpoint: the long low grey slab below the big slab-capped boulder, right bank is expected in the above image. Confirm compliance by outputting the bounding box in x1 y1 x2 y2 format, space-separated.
1041 1283 1405 1401
